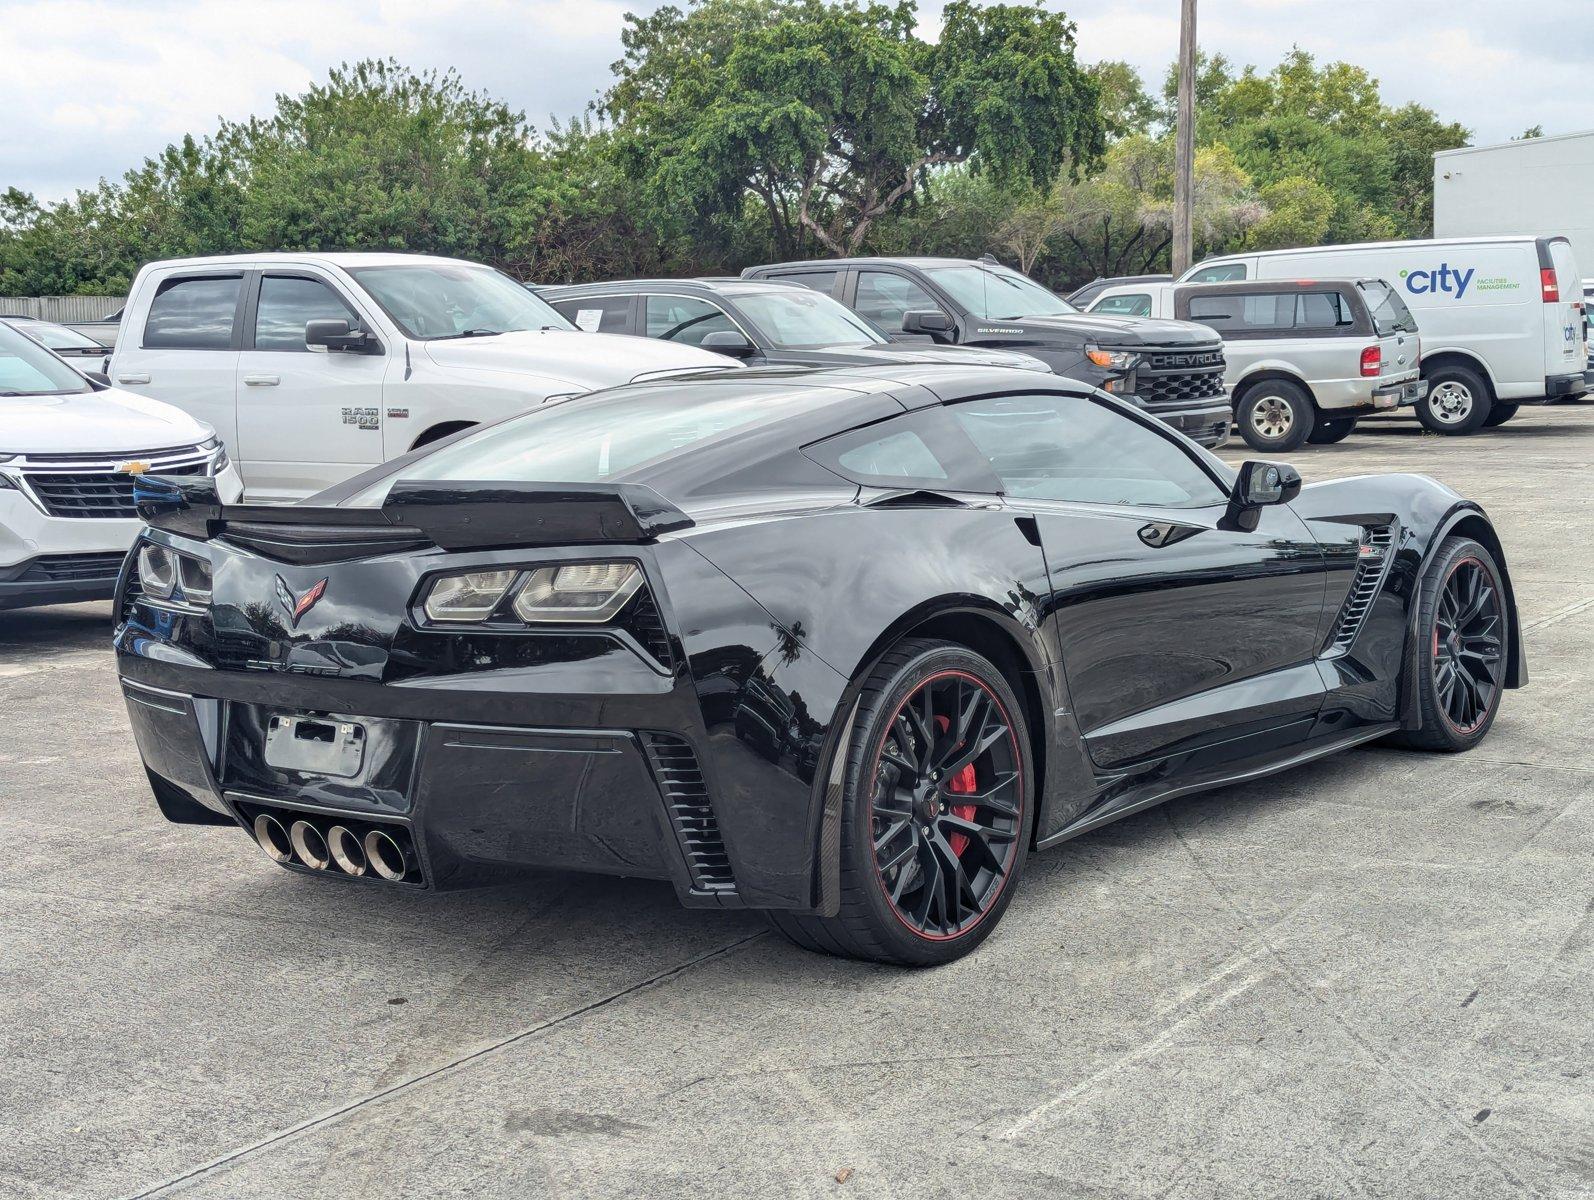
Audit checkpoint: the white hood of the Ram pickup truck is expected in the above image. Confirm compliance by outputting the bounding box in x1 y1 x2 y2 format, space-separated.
426 330 741 390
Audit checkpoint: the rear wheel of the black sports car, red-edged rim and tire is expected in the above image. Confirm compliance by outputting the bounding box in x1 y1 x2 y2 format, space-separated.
768 637 1035 966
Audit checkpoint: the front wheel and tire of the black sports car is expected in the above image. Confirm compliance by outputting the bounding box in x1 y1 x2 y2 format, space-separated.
1393 537 1511 754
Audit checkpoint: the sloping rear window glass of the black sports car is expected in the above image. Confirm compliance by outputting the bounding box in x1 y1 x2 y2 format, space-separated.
346 389 771 508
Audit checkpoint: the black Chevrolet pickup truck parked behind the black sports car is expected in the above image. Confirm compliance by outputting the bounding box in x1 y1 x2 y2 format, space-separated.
741 258 1234 446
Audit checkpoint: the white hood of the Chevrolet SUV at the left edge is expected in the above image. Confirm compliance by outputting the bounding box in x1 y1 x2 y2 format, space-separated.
0 387 215 454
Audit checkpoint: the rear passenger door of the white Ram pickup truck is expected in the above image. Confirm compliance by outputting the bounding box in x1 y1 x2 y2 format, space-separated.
110 269 245 457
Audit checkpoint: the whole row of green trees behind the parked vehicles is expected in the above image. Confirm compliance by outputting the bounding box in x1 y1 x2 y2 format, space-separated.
0 29 1466 295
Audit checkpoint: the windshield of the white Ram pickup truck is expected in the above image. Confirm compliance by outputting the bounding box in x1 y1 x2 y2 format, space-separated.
349 263 575 341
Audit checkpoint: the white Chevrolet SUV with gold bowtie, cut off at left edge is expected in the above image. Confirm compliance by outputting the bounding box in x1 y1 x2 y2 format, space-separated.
0 324 244 610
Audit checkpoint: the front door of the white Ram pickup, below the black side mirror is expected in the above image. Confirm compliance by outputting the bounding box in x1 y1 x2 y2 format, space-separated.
236 268 389 504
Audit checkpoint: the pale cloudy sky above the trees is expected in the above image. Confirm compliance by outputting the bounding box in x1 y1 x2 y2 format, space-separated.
0 0 1594 199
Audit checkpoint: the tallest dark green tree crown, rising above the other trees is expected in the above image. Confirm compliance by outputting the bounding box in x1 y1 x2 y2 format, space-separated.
604 0 1103 253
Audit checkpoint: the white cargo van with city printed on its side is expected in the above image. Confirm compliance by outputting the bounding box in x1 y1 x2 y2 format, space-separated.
1178 237 1588 433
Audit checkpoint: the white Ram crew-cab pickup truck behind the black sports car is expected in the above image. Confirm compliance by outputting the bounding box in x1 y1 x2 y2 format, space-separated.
110 253 741 502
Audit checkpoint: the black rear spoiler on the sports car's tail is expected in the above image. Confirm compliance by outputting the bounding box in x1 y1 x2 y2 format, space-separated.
132 475 692 550
